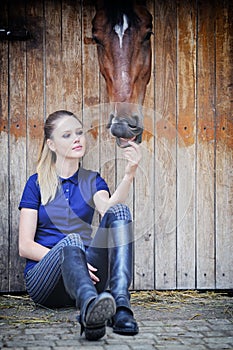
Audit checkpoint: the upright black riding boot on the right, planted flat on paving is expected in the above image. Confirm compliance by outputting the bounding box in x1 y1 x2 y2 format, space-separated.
109 220 139 335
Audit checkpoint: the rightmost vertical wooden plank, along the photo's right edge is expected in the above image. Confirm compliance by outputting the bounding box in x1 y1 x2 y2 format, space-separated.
216 0 233 289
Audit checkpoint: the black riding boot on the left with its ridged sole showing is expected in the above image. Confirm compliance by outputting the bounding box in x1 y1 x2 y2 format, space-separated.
61 246 116 340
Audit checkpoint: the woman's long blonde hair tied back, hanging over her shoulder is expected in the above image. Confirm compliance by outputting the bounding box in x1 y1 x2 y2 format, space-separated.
37 110 82 205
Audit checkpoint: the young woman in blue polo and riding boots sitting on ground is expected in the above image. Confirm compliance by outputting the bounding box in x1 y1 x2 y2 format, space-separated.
19 110 141 340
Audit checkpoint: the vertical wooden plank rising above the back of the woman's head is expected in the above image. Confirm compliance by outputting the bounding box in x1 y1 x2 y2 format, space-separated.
44 0 64 117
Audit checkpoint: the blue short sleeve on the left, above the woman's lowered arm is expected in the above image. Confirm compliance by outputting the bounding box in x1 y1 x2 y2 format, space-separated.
19 174 41 210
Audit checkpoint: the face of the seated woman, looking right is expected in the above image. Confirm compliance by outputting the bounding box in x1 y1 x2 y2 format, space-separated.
47 116 86 160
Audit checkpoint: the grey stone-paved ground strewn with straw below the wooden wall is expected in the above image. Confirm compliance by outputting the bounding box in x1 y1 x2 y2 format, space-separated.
0 291 233 350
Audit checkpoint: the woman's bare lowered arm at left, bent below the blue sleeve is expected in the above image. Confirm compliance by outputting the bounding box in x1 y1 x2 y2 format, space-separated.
19 208 49 261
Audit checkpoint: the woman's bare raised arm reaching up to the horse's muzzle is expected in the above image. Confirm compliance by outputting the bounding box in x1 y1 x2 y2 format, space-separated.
94 141 141 216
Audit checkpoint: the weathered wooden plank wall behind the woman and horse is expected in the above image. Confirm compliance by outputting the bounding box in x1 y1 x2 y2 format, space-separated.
0 0 233 291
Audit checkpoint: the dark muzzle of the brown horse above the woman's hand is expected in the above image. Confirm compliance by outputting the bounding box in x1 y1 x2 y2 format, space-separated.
107 115 143 148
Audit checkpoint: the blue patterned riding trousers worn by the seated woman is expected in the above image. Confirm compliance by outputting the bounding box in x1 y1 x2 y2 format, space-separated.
25 204 131 307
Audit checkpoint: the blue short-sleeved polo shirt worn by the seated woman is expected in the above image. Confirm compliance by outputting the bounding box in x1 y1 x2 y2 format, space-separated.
19 168 109 273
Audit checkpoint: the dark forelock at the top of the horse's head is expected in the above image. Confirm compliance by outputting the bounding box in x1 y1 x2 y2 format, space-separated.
100 0 140 26
